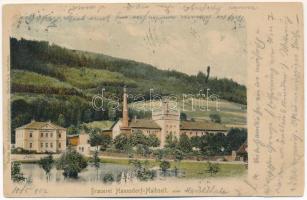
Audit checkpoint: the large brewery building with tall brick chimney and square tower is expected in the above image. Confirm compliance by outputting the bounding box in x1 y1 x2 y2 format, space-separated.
111 86 228 147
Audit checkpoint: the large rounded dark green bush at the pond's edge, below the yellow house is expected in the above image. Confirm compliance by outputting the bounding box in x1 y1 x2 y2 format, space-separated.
56 149 87 178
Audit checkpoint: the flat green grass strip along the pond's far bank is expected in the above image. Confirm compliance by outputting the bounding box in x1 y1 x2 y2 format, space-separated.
102 158 247 178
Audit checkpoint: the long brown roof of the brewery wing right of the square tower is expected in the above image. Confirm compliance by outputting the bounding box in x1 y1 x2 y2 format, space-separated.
180 121 228 131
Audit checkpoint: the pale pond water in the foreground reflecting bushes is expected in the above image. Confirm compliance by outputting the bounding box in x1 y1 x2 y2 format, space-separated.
21 163 184 183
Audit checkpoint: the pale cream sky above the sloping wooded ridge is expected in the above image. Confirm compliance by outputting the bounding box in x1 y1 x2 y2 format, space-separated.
12 11 247 84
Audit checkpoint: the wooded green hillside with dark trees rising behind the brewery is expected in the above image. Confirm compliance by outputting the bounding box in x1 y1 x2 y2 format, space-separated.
10 38 246 141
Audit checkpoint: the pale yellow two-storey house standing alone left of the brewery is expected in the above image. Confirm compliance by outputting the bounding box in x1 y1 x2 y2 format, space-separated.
15 120 66 153
